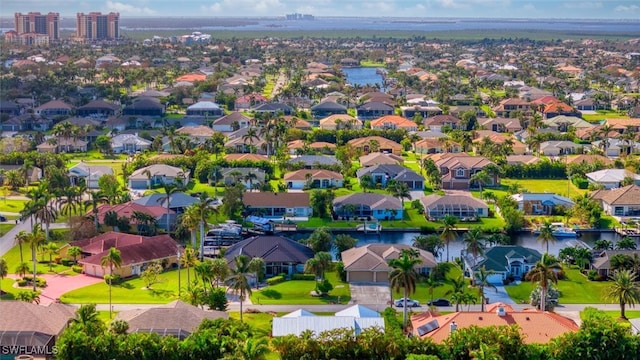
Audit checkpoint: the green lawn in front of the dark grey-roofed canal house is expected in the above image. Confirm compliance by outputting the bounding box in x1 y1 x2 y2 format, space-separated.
251 273 351 305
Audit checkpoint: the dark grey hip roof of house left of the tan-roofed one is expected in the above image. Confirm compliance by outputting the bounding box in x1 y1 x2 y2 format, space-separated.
224 236 315 265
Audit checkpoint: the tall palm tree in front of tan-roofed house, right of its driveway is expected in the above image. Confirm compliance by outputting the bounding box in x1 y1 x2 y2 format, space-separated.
389 249 422 328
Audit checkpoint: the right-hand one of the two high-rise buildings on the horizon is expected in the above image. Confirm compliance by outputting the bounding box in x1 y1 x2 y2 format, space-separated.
76 12 120 40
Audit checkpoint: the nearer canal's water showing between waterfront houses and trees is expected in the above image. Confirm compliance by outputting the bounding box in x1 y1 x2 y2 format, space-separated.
291 231 624 260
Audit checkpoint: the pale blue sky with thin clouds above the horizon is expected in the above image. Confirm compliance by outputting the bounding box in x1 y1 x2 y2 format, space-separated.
0 0 640 19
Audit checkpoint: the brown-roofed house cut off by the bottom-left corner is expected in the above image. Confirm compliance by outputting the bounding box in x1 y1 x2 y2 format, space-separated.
0 300 76 359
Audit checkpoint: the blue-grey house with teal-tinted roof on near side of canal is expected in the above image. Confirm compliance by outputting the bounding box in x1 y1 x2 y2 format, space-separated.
465 245 542 284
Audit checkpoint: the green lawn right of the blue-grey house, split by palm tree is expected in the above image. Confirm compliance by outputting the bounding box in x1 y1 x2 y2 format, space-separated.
505 269 611 304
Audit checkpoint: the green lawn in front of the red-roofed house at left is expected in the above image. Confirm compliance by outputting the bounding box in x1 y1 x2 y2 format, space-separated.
60 269 188 304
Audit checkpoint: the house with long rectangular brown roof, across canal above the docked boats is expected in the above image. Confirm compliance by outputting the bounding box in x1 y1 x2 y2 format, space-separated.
242 192 313 221
